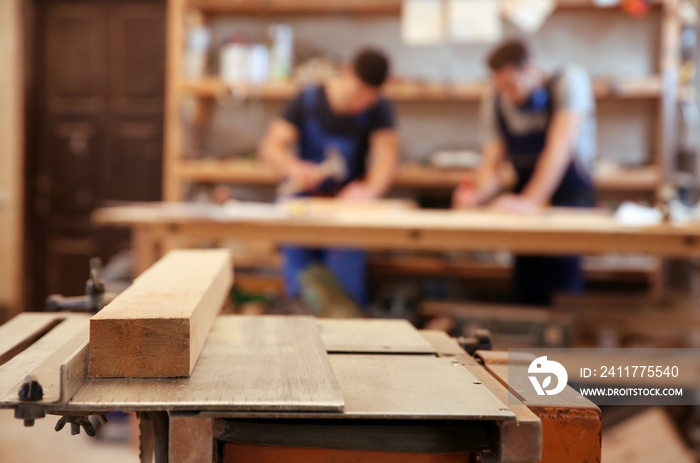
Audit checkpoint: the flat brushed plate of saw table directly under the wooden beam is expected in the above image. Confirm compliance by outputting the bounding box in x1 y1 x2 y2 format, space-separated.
71 315 345 412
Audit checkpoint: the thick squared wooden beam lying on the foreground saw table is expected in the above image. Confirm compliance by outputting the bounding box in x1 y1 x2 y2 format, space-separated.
90 249 233 378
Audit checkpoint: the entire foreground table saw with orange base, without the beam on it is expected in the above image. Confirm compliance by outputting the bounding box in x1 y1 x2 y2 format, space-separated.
0 313 600 463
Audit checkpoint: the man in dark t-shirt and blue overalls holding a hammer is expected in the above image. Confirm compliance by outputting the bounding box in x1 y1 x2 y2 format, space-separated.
260 49 399 307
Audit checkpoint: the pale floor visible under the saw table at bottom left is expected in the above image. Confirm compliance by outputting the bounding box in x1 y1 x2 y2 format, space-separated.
0 410 139 463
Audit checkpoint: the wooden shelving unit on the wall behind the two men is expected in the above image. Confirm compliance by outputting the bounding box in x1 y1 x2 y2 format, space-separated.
163 0 680 201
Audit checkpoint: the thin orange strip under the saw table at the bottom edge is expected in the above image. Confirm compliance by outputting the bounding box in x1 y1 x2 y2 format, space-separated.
224 442 469 463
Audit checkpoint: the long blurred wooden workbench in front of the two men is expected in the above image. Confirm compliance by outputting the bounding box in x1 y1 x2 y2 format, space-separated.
93 203 700 274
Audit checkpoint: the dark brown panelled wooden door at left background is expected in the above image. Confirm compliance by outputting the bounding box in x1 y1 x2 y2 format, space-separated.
26 0 165 309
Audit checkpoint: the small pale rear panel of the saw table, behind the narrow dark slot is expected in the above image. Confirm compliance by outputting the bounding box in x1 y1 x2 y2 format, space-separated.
316 319 435 354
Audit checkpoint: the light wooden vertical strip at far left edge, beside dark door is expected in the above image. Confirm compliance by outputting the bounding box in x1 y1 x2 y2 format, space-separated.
0 0 24 321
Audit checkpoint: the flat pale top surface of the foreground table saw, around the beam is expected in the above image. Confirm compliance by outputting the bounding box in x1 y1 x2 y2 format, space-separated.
0 314 514 421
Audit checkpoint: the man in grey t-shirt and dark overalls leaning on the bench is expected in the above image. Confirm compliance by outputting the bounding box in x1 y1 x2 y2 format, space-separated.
453 40 596 305
